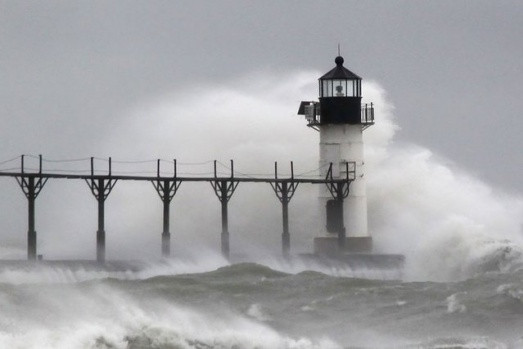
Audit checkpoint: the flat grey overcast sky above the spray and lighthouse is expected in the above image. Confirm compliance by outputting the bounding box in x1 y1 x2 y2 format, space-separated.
0 0 523 193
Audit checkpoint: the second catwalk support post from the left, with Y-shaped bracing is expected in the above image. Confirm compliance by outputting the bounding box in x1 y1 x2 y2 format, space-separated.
85 158 118 263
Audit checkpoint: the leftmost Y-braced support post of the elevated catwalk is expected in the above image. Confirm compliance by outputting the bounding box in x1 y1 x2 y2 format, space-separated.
15 155 48 260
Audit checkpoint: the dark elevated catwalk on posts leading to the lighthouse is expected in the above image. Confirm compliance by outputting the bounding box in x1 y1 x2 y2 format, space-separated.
0 155 402 267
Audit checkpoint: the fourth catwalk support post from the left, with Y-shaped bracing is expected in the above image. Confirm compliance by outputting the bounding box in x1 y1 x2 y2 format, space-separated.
211 160 239 259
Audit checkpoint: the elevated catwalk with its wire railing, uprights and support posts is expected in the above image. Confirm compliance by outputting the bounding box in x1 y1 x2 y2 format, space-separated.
0 155 356 263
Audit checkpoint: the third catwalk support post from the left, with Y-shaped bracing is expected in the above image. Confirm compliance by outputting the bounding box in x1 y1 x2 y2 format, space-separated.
151 160 182 258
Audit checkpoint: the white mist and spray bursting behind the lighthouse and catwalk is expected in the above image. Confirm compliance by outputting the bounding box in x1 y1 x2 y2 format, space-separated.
0 71 523 280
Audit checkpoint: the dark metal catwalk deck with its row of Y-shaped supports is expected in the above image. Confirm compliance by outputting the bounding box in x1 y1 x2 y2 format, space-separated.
0 155 355 262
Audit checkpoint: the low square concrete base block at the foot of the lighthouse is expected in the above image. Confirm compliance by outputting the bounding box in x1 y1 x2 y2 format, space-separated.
314 236 372 256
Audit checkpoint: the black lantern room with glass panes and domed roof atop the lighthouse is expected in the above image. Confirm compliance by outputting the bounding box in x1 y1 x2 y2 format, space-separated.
318 56 361 124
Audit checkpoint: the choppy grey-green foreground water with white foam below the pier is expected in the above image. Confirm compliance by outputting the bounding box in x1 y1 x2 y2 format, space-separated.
0 260 523 349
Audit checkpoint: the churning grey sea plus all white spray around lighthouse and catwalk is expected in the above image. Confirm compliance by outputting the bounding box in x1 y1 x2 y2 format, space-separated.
0 72 523 349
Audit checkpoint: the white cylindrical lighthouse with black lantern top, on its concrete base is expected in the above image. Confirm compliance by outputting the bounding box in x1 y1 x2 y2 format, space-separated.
298 56 374 255
